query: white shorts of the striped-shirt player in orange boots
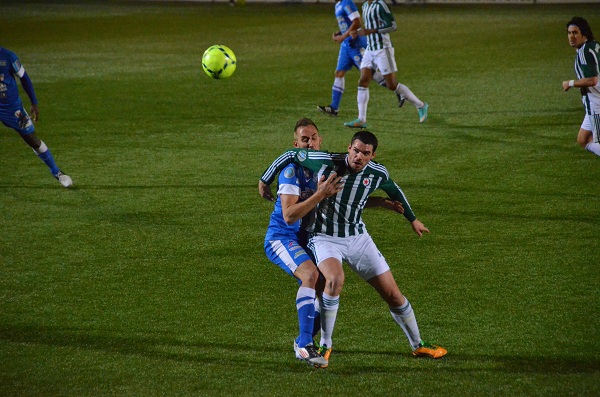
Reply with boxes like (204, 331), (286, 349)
(308, 232), (390, 281)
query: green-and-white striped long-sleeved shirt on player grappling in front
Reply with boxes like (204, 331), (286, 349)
(261, 149), (417, 237)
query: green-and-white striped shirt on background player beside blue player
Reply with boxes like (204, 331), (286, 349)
(362, 0), (396, 51)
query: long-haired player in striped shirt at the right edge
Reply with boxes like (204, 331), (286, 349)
(562, 17), (600, 156)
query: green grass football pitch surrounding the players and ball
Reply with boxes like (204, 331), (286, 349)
(0, 1), (600, 397)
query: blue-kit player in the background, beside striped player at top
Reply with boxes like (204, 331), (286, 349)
(317, 0), (404, 116)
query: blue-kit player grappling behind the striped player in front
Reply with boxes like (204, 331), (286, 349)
(264, 119), (341, 368)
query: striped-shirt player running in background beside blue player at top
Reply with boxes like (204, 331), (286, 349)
(344, 0), (429, 128)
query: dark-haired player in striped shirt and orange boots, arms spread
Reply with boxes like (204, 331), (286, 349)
(261, 130), (447, 358)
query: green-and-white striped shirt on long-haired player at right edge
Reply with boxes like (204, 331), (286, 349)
(575, 40), (600, 114)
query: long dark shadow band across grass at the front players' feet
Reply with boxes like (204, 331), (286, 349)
(0, 325), (600, 375)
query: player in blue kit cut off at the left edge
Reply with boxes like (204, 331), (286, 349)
(0, 47), (73, 187)
